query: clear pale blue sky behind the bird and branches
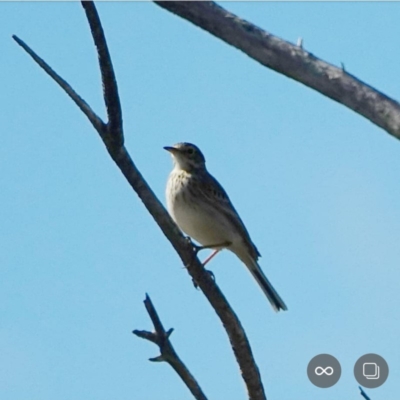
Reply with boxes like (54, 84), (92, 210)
(0, 2), (400, 400)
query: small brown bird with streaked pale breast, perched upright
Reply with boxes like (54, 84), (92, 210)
(164, 142), (287, 311)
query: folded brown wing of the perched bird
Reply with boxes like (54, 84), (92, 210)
(194, 172), (261, 261)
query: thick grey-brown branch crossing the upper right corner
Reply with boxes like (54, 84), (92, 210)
(155, 1), (400, 139)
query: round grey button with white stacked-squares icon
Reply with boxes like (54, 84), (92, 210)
(354, 353), (389, 389)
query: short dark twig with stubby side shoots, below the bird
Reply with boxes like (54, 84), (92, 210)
(133, 294), (207, 400)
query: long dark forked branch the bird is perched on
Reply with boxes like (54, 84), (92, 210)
(13, 1), (266, 400)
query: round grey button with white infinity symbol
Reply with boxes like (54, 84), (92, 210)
(307, 354), (342, 388)
